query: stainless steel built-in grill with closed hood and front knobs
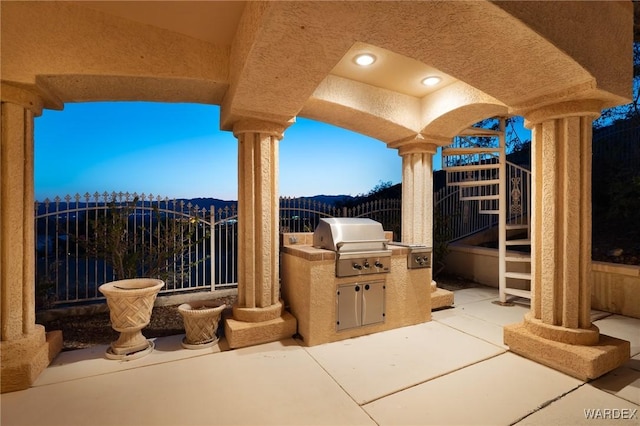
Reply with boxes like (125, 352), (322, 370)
(313, 218), (391, 277)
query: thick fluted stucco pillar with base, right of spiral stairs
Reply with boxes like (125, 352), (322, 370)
(504, 101), (630, 380)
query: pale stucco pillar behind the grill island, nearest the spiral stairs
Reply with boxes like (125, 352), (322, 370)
(390, 135), (453, 309)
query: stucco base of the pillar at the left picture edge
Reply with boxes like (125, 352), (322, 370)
(0, 325), (62, 393)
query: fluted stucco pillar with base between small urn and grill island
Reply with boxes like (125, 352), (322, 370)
(225, 119), (296, 348)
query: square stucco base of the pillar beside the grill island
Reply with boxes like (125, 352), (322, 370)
(224, 310), (298, 349)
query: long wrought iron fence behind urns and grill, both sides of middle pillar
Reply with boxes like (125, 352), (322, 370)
(35, 192), (401, 309)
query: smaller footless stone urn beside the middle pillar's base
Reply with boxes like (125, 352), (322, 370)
(178, 300), (227, 349)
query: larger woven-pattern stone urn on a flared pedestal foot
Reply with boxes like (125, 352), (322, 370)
(98, 278), (164, 360)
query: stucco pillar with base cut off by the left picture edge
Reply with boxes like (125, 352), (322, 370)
(0, 83), (62, 392)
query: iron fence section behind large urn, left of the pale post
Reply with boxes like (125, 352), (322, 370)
(35, 192), (217, 305)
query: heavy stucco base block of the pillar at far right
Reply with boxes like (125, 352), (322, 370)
(504, 323), (631, 381)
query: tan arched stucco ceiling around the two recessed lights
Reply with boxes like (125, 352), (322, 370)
(0, 1), (637, 142)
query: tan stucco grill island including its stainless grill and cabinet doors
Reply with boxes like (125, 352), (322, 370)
(281, 218), (431, 346)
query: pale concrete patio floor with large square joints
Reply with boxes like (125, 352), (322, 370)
(1, 287), (640, 426)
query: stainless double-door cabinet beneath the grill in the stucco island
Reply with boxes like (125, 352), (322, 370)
(336, 281), (385, 331)
